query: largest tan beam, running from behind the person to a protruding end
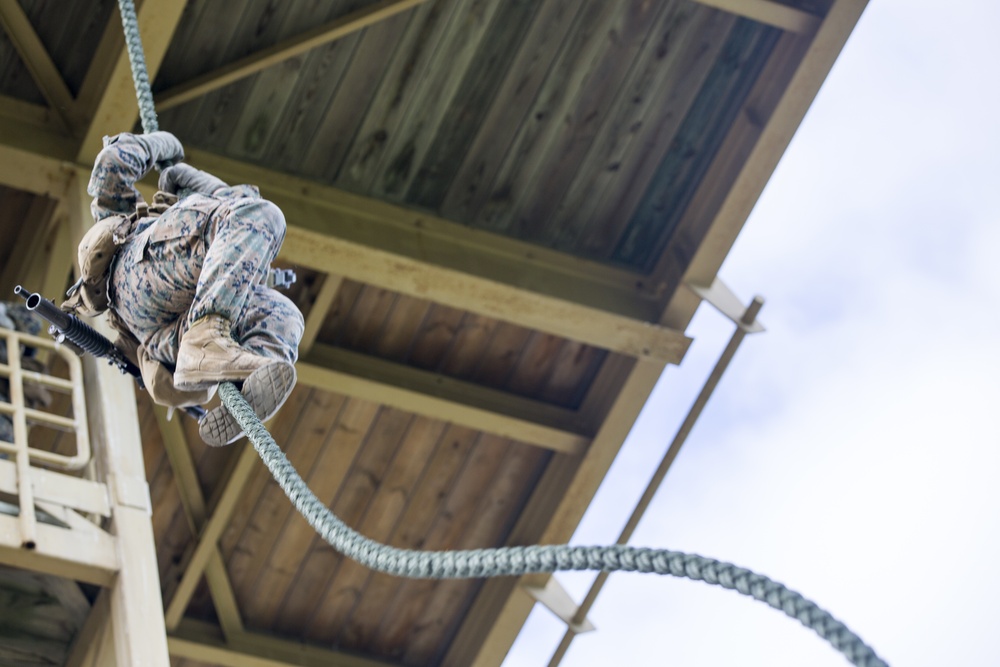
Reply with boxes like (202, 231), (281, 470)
(0, 137), (690, 363)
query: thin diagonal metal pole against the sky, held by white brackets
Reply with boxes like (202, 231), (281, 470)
(549, 297), (764, 667)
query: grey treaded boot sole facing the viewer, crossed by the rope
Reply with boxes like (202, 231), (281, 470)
(198, 361), (296, 447)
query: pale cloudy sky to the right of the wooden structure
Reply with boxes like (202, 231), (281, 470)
(504, 0), (1000, 667)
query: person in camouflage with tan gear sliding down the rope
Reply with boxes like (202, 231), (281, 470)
(63, 132), (304, 446)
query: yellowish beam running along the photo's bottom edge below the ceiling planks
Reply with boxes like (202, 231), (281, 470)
(167, 619), (391, 667)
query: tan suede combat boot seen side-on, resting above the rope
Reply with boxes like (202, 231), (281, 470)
(174, 315), (274, 391)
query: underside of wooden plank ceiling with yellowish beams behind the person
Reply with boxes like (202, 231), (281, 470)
(0, 0), (865, 665)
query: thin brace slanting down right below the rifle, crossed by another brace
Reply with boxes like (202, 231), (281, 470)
(154, 406), (243, 637)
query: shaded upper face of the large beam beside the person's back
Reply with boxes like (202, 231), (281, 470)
(187, 149), (662, 322)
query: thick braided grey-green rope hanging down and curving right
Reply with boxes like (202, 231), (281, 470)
(118, 0), (888, 667)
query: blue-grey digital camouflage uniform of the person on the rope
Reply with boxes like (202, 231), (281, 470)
(88, 134), (304, 365)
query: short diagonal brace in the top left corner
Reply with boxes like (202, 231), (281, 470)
(0, 0), (80, 128)
